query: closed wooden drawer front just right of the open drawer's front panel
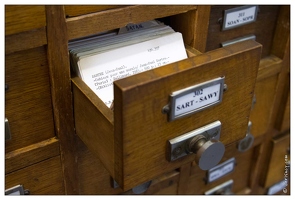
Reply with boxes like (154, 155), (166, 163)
(250, 56), (282, 137)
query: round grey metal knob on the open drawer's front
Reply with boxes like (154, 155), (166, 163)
(188, 135), (225, 170)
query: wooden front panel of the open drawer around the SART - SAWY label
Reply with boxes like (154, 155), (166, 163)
(114, 41), (261, 188)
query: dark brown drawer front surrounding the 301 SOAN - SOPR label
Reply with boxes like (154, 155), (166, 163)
(206, 5), (279, 57)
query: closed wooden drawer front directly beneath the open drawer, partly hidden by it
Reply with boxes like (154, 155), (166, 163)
(77, 137), (179, 195)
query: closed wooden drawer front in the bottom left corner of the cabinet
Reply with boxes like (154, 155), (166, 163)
(5, 156), (65, 195)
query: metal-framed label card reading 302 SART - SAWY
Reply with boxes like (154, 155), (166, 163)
(168, 77), (224, 121)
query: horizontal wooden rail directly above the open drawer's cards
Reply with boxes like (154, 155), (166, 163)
(67, 5), (197, 40)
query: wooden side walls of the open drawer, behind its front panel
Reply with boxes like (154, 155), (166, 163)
(72, 47), (200, 181)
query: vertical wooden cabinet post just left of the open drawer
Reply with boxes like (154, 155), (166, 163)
(46, 6), (79, 194)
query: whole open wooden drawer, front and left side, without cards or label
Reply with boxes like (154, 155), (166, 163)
(72, 41), (261, 191)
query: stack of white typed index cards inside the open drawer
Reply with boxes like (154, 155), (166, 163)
(69, 20), (187, 107)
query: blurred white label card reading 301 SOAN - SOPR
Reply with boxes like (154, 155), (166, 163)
(222, 6), (258, 31)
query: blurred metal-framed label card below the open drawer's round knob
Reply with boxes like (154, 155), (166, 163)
(207, 158), (236, 183)
